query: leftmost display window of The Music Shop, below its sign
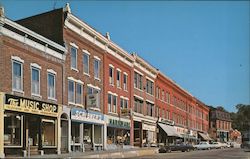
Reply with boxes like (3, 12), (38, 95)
(4, 113), (23, 146)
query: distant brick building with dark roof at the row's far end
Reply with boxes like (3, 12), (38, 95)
(209, 107), (232, 142)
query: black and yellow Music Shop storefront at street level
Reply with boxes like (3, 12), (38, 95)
(4, 94), (59, 156)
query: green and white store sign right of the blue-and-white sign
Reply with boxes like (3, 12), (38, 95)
(105, 115), (130, 129)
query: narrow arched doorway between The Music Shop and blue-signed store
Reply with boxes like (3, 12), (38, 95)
(61, 114), (69, 153)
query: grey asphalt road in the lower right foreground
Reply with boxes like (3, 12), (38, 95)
(133, 148), (250, 159)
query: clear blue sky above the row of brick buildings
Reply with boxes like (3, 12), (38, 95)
(0, 0), (250, 112)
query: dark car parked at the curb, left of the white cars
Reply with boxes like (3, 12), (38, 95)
(159, 144), (195, 153)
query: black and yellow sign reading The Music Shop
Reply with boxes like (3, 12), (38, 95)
(4, 94), (58, 117)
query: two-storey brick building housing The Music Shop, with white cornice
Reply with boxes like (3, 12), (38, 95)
(0, 8), (65, 157)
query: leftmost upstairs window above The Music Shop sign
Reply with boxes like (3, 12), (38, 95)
(12, 60), (23, 91)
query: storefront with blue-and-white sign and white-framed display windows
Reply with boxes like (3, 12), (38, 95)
(71, 108), (105, 151)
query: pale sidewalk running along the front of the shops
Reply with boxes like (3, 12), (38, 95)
(6, 147), (158, 159)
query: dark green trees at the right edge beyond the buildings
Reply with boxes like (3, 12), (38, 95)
(230, 104), (250, 132)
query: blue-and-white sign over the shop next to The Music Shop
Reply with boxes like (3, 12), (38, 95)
(71, 108), (104, 124)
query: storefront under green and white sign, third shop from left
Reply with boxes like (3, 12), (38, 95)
(105, 115), (131, 150)
